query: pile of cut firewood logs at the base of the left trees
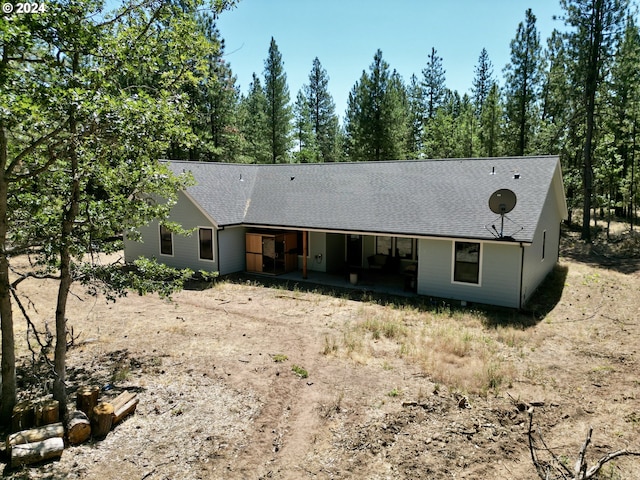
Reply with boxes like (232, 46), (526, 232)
(4, 386), (139, 468)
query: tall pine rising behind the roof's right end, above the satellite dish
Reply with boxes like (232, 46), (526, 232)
(504, 9), (543, 155)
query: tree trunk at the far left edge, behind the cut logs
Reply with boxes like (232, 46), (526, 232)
(0, 121), (16, 425)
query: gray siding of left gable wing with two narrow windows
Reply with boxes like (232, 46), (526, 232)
(124, 192), (219, 271)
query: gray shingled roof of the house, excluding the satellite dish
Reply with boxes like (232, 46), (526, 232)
(168, 156), (566, 242)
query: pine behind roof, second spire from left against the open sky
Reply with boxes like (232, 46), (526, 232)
(306, 57), (338, 162)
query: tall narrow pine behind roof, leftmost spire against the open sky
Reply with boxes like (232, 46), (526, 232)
(264, 37), (292, 163)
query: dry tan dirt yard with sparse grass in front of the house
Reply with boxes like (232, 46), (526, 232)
(4, 230), (640, 480)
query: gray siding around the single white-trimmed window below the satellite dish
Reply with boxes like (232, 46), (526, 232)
(418, 239), (521, 307)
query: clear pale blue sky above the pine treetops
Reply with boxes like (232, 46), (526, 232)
(218, 0), (564, 118)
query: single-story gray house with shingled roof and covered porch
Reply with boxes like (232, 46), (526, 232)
(125, 156), (567, 308)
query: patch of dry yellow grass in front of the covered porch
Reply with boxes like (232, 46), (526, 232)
(322, 304), (535, 395)
